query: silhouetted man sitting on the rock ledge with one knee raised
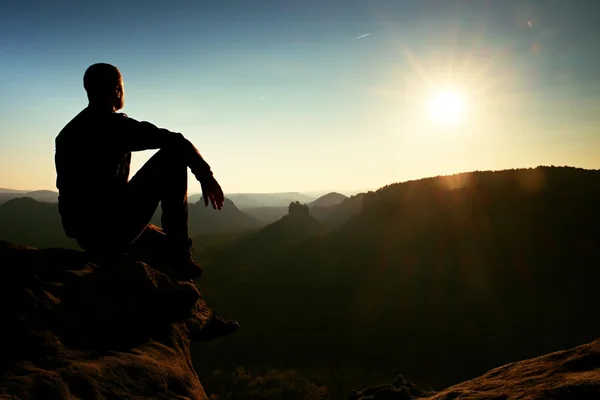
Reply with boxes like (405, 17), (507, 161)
(55, 63), (224, 280)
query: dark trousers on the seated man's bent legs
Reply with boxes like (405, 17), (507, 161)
(77, 150), (189, 252)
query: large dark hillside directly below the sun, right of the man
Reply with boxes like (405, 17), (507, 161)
(194, 167), (600, 387)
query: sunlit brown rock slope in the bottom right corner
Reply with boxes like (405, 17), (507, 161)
(349, 339), (600, 400)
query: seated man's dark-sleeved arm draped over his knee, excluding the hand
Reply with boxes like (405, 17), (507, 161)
(115, 114), (212, 182)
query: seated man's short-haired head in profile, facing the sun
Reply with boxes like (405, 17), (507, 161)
(83, 63), (125, 111)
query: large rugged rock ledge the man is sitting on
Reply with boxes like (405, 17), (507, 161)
(0, 242), (238, 400)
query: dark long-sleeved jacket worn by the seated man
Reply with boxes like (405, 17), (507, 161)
(55, 107), (212, 238)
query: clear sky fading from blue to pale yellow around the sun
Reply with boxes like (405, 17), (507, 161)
(0, 0), (600, 193)
